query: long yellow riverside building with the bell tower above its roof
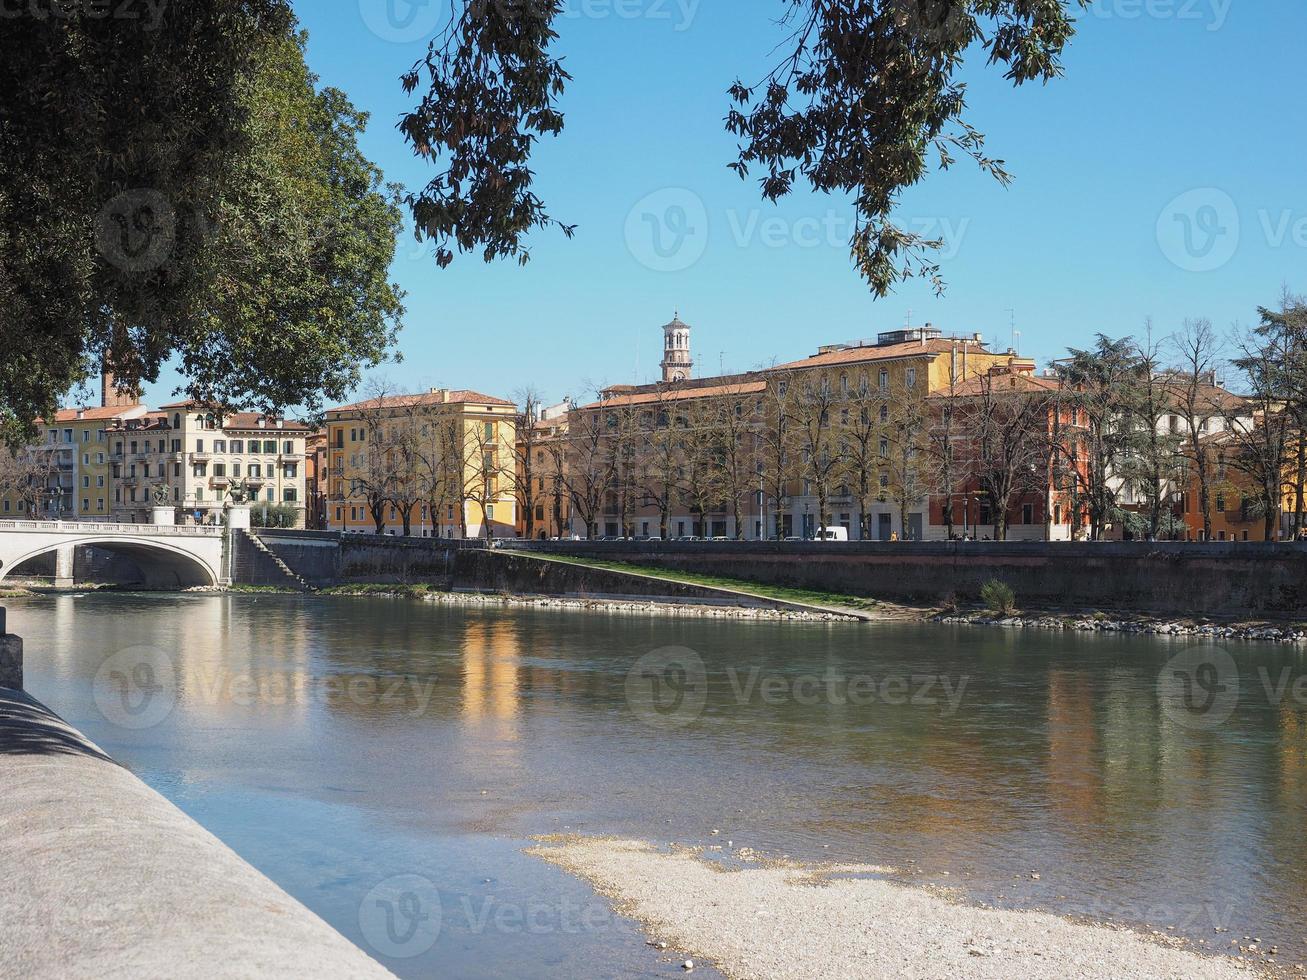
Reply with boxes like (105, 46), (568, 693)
(567, 318), (1034, 540)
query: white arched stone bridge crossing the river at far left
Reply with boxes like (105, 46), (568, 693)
(0, 520), (231, 588)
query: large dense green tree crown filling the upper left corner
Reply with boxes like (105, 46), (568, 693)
(0, 7), (401, 439)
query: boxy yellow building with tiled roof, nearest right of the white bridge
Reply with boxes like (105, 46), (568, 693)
(325, 388), (518, 538)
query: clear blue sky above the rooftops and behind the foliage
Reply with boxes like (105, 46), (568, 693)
(137, 0), (1307, 401)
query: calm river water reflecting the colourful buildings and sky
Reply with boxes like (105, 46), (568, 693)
(8, 595), (1307, 977)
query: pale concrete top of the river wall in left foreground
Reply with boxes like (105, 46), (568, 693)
(0, 690), (391, 980)
